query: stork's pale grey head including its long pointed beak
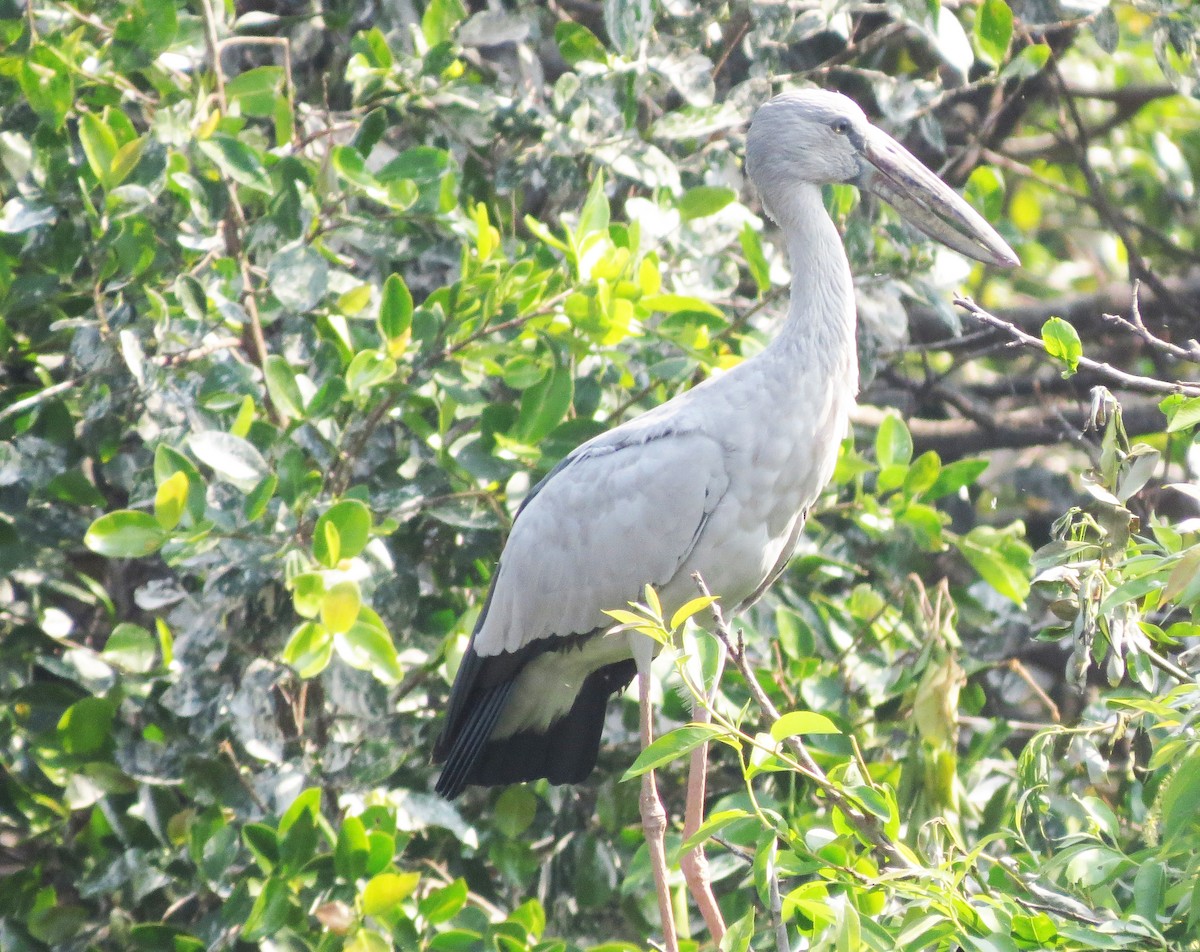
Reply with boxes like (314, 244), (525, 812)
(746, 89), (1020, 268)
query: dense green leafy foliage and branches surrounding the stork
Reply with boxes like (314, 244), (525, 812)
(0, 0), (1200, 952)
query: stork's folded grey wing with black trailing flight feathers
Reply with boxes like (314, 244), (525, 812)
(434, 418), (728, 797)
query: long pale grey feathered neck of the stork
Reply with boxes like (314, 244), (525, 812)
(770, 185), (858, 394)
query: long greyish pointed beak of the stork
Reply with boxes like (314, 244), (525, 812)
(858, 126), (1021, 268)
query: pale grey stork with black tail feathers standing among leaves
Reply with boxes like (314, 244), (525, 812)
(434, 89), (1019, 941)
